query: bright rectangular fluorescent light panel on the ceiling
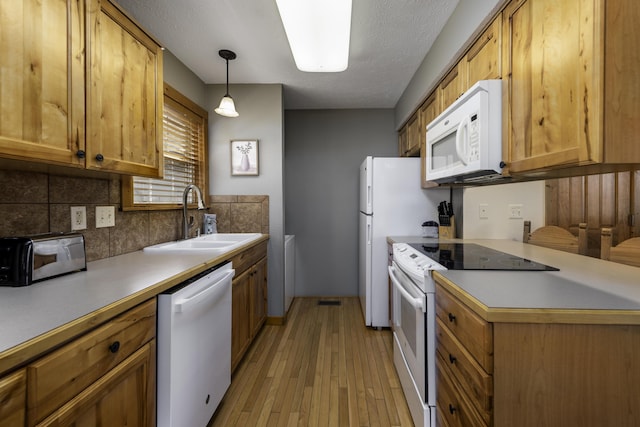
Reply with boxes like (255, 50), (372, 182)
(276, 0), (352, 73)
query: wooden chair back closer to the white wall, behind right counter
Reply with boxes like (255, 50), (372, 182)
(522, 221), (587, 255)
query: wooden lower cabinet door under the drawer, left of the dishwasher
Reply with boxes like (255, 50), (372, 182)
(38, 339), (156, 427)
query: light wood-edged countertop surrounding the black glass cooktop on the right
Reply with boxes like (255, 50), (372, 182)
(389, 237), (640, 324)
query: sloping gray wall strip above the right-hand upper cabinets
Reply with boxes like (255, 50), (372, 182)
(395, 0), (506, 129)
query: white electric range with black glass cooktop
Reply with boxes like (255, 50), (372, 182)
(389, 240), (557, 427)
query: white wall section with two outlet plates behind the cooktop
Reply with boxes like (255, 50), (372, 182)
(462, 181), (545, 241)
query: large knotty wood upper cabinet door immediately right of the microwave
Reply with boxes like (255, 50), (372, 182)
(503, 0), (602, 176)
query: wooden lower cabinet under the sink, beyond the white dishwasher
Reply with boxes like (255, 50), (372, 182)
(231, 242), (267, 372)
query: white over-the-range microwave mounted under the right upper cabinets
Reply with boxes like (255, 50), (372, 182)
(425, 80), (504, 184)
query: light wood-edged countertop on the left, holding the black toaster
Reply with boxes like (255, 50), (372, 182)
(0, 235), (268, 374)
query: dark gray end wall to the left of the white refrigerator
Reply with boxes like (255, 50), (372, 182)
(285, 109), (398, 296)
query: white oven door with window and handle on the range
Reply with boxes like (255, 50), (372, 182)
(389, 262), (427, 403)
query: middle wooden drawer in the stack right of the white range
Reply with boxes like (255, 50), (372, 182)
(436, 318), (493, 423)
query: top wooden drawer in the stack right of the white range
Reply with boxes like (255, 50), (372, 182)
(436, 283), (493, 374)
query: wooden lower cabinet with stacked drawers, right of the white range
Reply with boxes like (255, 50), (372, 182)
(436, 283), (640, 427)
